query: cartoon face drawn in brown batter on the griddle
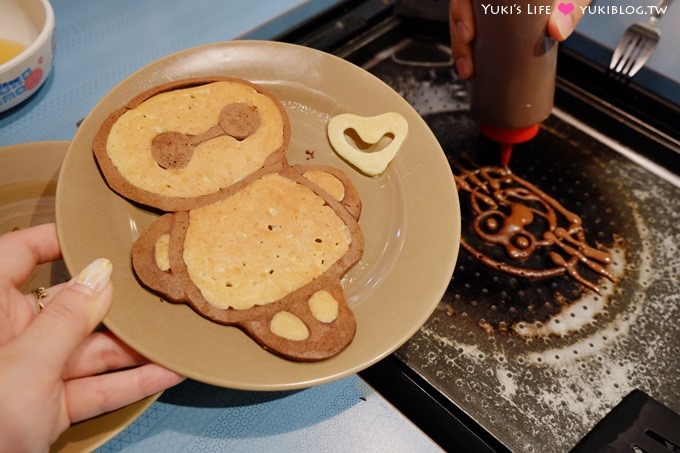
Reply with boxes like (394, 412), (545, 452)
(453, 162), (615, 293)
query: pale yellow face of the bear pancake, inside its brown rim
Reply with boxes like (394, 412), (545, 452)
(106, 81), (285, 197)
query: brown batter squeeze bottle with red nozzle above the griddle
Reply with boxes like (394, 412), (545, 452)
(470, 0), (557, 166)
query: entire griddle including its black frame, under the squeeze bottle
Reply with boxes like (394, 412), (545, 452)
(276, 1), (680, 452)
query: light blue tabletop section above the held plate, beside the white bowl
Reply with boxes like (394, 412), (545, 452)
(0, 0), (346, 146)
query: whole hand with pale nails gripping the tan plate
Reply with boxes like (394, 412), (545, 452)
(0, 224), (183, 451)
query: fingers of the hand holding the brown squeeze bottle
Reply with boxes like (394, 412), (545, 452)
(449, 0), (591, 79)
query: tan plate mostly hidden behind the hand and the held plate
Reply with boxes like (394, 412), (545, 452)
(0, 141), (160, 452)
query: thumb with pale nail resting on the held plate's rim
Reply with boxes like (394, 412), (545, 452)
(20, 258), (113, 373)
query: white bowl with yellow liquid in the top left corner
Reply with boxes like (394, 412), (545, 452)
(0, 0), (54, 112)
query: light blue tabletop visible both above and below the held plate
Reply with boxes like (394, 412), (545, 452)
(0, 0), (439, 452)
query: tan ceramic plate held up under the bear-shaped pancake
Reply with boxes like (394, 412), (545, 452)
(57, 41), (460, 390)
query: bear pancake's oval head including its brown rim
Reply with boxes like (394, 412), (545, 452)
(94, 77), (290, 211)
